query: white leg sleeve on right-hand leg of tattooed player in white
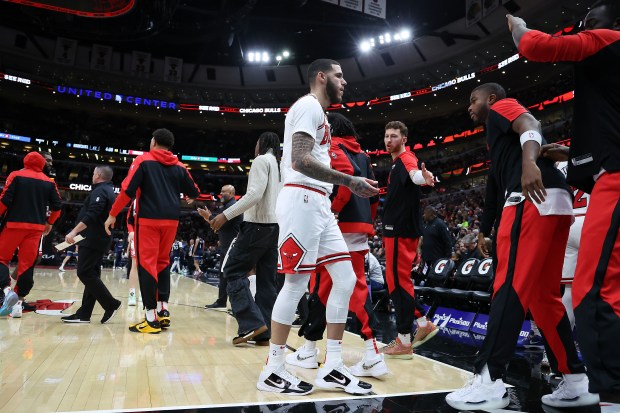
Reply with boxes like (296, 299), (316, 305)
(325, 261), (356, 324)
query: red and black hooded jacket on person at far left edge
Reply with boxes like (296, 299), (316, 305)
(0, 152), (62, 231)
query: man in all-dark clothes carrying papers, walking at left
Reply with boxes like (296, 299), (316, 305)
(62, 166), (121, 324)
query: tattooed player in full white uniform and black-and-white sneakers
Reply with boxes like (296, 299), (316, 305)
(256, 59), (379, 396)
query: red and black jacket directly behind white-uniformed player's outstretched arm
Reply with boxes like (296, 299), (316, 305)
(329, 136), (379, 235)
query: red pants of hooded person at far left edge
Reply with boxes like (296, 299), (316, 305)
(0, 228), (43, 297)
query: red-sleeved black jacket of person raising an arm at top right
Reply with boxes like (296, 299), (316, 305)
(519, 29), (620, 193)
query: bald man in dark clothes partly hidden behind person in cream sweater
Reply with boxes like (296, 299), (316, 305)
(205, 185), (243, 309)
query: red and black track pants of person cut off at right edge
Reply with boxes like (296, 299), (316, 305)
(573, 172), (620, 394)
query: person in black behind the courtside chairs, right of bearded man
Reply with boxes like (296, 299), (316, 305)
(419, 206), (454, 274)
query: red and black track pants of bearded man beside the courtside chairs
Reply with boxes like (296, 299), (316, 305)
(383, 237), (422, 334)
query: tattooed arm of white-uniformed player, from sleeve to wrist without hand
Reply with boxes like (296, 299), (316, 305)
(291, 132), (352, 186)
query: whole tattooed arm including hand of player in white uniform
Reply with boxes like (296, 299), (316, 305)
(291, 132), (379, 198)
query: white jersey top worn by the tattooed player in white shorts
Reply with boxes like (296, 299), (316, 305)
(280, 95), (333, 193)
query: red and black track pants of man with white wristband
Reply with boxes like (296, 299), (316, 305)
(474, 201), (585, 380)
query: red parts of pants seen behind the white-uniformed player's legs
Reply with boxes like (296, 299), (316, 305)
(310, 250), (374, 340)
